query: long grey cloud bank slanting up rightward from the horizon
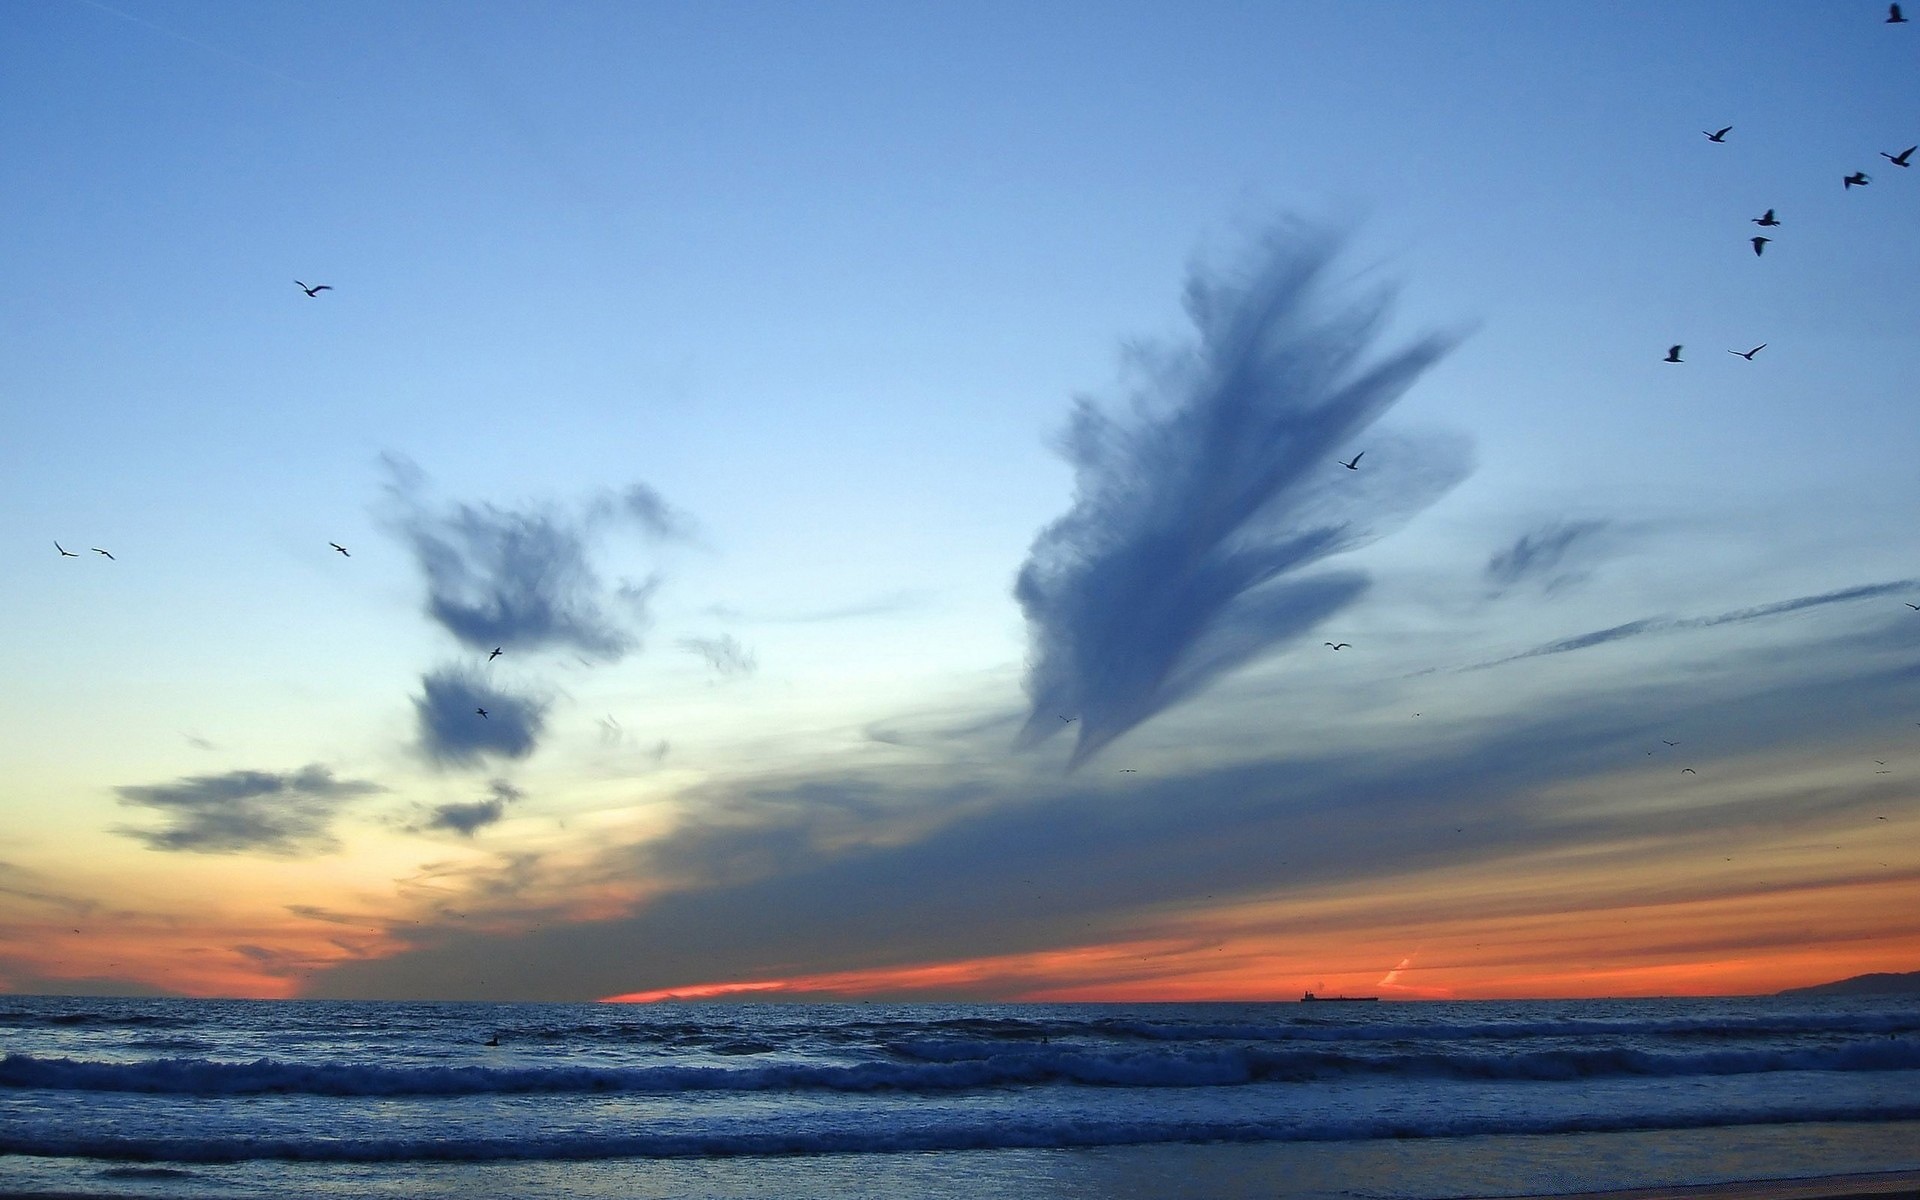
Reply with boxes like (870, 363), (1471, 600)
(303, 606), (1920, 1000)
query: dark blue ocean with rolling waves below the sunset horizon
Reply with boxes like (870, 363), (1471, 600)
(0, 996), (1920, 1200)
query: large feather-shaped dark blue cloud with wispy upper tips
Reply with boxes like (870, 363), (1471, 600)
(1014, 228), (1471, 764)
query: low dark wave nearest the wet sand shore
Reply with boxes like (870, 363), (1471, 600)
(0, 1100), (1920, 1164)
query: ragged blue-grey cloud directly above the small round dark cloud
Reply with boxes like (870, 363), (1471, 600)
(386, 457), (685, 660)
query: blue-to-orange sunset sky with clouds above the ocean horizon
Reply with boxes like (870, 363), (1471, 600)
(0, 0), (1920, 1000)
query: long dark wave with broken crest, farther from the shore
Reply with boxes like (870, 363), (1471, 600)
(0, 1039), (1920, 1096)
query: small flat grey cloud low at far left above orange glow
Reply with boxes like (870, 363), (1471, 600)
(115, 764), (386, 858)
